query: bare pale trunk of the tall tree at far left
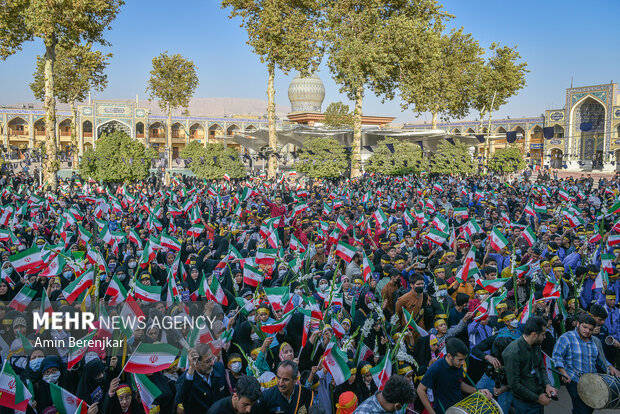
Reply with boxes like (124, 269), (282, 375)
(42, 40), (59, 191)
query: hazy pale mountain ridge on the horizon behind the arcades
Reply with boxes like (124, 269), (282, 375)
(6, 98), (291, 118)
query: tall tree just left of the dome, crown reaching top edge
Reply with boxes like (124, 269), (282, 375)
(222, 0), (324, 178)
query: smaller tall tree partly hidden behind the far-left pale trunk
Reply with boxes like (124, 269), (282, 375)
(30, 43), (112, 167)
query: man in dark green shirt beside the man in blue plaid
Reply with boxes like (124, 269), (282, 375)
(502, 316), (557, 414)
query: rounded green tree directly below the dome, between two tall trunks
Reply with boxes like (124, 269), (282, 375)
(294, 138), (349, 178)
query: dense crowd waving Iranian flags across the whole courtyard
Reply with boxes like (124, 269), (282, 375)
(0, 172), (620, 414)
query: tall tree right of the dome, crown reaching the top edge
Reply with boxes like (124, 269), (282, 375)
(325, 0), (444, 177)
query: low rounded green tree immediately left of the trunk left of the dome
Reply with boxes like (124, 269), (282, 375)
(180, 141), (246, 180)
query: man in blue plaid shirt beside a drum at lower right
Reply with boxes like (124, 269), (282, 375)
(553, 313), (620, 414)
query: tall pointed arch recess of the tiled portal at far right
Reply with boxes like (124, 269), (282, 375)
(574, 97), (605, 169)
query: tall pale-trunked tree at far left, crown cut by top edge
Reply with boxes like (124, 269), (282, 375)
(0, 0), (124, 190)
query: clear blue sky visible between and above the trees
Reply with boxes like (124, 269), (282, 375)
(0, 0), (620, 123)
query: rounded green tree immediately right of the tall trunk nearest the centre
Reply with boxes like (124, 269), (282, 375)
(364, 137), (424, 175)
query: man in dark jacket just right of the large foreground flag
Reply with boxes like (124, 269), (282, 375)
(177, 344), (230, 413)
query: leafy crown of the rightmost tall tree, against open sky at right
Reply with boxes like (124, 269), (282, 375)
(472, 43), (529, 114)
